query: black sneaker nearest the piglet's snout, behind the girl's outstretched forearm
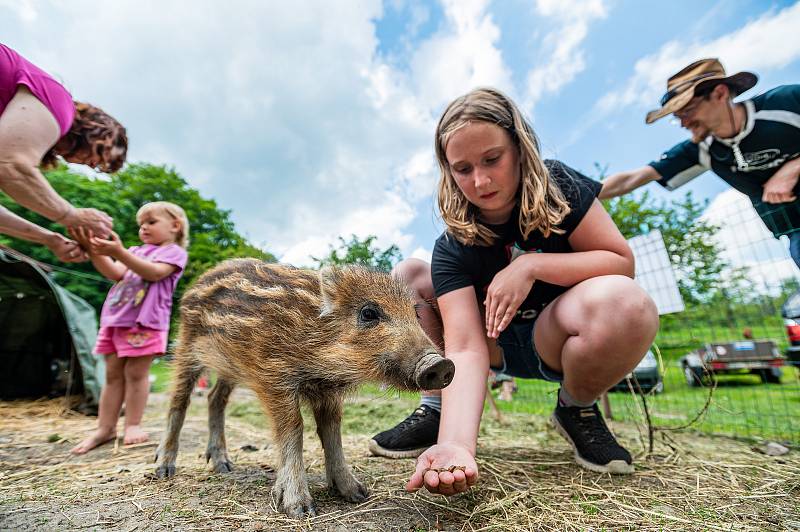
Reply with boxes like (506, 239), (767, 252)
(369, 405), (440, 458)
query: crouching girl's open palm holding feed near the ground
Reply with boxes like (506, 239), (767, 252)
(406, 443), (478, 495)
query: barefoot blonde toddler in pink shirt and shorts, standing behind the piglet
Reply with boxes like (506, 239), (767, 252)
(71, 201), (189, 454)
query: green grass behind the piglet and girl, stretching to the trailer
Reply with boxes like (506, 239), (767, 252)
(150, 351), (800, 443)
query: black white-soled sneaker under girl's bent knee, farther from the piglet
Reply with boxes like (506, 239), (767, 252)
(551, 403), (634, 475)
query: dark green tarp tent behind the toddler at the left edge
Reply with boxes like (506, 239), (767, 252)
(0, 246), (105, 413)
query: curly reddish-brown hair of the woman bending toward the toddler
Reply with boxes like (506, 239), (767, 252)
(42, 102), (128, 173)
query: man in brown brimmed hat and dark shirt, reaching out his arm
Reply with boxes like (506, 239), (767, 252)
(600, 59), (800, 267)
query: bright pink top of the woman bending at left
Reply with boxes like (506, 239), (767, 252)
(0, 44), (75, 137)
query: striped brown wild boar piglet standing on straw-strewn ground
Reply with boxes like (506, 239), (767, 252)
(156, 259), (455, 517)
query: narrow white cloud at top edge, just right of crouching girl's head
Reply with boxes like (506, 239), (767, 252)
(524, 0), (606, 109)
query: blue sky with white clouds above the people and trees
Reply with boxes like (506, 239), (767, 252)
(0, 0), (800, 264)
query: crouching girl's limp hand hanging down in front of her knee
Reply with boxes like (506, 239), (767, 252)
(483, 253), (536, 338)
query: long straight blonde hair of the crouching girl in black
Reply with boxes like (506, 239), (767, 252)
(435, 88), (570, 246)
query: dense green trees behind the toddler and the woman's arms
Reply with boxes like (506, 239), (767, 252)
(0, 164), (275, 311)
